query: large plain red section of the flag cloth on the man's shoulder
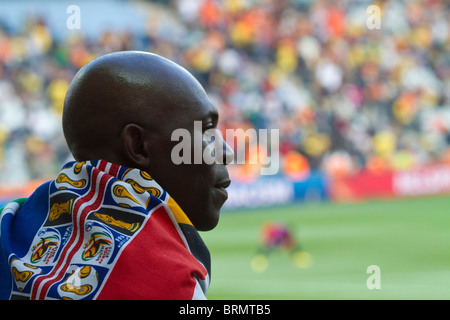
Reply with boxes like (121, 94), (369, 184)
(97, 207), (207, 300)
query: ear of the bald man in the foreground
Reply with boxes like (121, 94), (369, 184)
(121, 123), (150, 168)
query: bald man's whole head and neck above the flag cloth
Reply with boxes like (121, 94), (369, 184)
(63, 51), (233, 231)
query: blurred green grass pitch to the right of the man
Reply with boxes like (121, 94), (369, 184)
(202, 197), (450, 300)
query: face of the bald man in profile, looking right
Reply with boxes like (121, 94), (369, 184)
(147, 87), (233, 231)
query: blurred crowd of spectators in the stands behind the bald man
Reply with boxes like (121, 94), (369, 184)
(0, 0), (450, 183)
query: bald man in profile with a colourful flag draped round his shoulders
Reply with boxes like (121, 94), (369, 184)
(0, 51), (233, 299)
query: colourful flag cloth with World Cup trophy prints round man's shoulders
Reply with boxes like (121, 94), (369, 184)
(0, 160), (210, 300)
